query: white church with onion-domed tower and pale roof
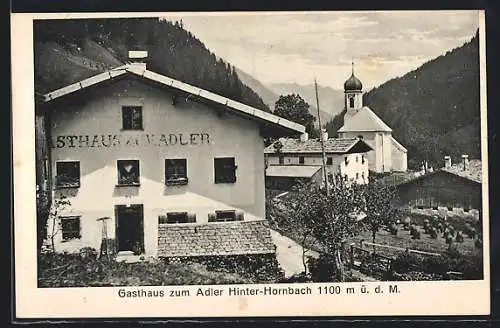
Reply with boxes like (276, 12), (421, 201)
(337, 66), (407, 173)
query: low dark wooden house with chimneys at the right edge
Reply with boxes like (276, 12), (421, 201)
(383, 155), (482, 218)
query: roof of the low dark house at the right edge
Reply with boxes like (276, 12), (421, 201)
(380, 159), (482, 186)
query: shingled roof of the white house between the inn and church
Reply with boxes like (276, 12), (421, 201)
(264, 138), (372, 154)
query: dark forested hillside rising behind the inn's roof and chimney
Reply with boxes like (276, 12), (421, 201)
(34, 18), (269, 111)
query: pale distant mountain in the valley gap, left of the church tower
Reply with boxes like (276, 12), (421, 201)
(268, 83), (344, 124)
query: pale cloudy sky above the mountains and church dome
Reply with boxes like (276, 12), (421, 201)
(165, 11), (479, 90)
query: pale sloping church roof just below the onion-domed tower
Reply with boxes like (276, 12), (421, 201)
(337, 106), (392, 132)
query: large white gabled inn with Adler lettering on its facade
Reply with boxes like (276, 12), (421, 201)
(37, 54), (305, 258)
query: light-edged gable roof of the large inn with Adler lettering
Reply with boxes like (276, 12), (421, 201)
(42, 63), (305, 133)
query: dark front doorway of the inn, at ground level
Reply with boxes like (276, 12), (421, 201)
(115, 204), (144, 254)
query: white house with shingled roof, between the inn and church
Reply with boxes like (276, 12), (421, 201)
(265, 132), (372, 190)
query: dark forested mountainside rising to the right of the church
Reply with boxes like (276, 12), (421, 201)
(328, 32), (481, 167)
